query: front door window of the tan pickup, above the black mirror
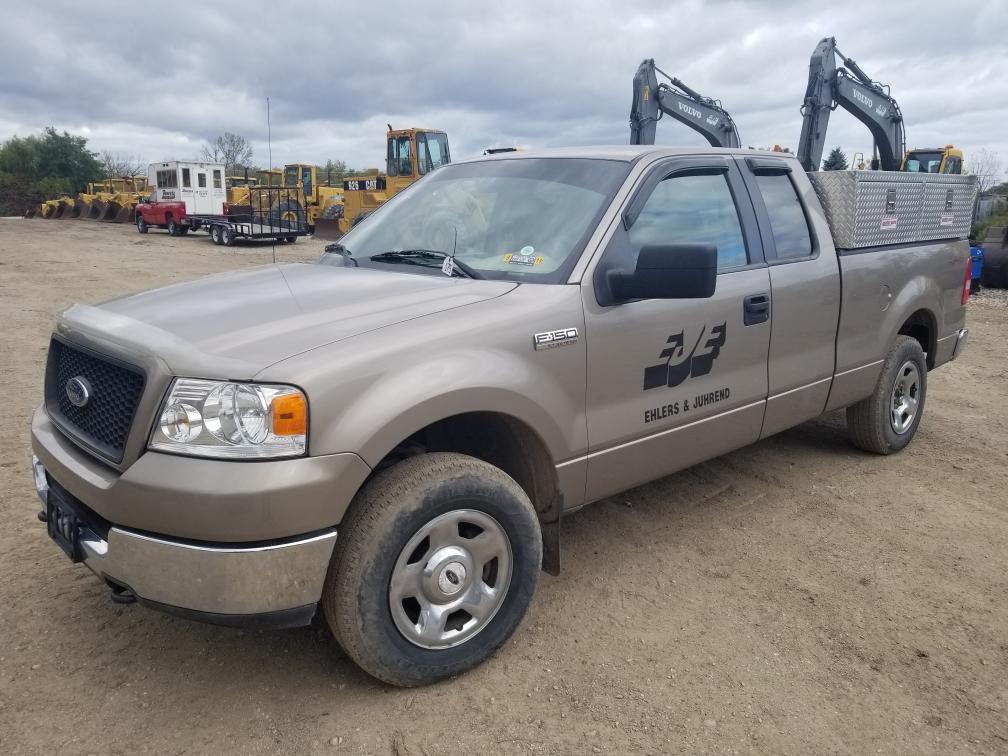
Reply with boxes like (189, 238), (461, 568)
(629, 172), (749, 271)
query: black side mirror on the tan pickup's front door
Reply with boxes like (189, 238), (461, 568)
(608, 244), (718, 302)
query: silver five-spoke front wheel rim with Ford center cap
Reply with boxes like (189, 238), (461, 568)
(388, 509), (513, 650)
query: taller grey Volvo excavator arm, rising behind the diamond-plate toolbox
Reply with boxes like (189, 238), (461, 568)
(797, 37), (906, 170)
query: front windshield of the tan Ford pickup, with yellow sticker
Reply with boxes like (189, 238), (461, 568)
(323, 158), (630, 283)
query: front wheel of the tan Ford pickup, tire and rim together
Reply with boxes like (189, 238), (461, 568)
(322, 453), (542, 686)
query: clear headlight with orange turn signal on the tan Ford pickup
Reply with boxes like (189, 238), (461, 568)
(148, 378), (308, 460)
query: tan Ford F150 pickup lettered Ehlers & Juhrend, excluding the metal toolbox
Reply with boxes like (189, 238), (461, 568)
(31, 146), (970, 685)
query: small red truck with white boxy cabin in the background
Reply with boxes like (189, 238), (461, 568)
(136, 160), (227, 236)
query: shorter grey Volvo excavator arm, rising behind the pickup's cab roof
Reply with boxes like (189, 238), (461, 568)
(630, 58), (741, 147)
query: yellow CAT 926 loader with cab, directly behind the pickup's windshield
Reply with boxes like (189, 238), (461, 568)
(312, 125), (452, 239)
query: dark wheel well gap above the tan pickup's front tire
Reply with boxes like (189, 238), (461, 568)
(369, 411), (558, 520)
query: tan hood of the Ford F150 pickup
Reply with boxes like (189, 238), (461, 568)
(57, 263), (517, 379)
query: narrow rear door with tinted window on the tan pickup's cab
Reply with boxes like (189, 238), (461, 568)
(737, 156), (840, 437)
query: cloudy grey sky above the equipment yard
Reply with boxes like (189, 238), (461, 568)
(0, 0), (1008, 173)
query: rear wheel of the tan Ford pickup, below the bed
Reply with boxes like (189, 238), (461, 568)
(847, 335), (927, 455)
